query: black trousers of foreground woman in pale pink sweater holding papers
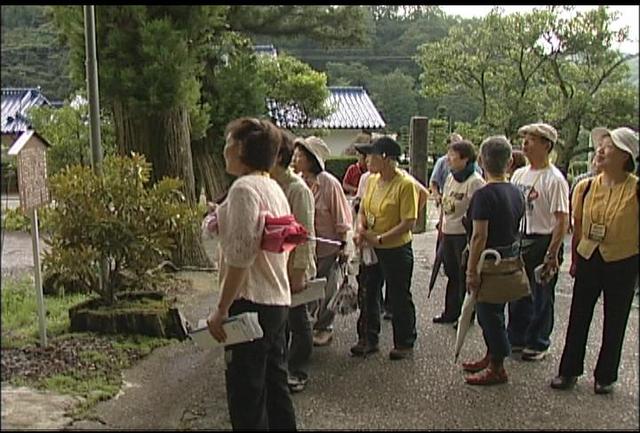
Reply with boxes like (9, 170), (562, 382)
(225, 299), (296, 430)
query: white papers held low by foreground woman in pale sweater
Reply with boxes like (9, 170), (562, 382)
(189, 311), (264, 349)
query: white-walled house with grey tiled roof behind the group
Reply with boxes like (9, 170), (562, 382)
(267, 86), (386, 156)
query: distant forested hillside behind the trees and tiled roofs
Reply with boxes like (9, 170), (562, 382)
(1, 6), (638, 147)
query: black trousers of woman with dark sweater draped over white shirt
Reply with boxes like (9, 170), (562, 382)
(442, 234), (467, 321)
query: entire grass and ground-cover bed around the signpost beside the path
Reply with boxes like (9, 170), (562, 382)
(1, 275), (176, 419)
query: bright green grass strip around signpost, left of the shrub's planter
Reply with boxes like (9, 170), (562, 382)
(0, 275), (91, 348)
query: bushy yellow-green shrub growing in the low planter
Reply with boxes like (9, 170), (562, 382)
(43, 155), (195, 304)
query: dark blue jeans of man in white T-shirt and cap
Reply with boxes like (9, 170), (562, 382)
(507, 235), (563, 351)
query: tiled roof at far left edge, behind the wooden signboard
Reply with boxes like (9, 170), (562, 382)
(2, 88), (51, 134)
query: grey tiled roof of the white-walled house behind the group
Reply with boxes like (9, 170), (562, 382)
(267, 87), (386, 129)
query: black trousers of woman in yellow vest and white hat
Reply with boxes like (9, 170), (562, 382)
(560, 250), (638, 384)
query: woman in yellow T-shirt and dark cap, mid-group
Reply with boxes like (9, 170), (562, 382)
(351, 137), (418, 360)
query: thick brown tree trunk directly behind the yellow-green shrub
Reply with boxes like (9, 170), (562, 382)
(114, 102), (211, 267)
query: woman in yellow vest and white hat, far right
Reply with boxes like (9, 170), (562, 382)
(551, 128), (638, 394)
